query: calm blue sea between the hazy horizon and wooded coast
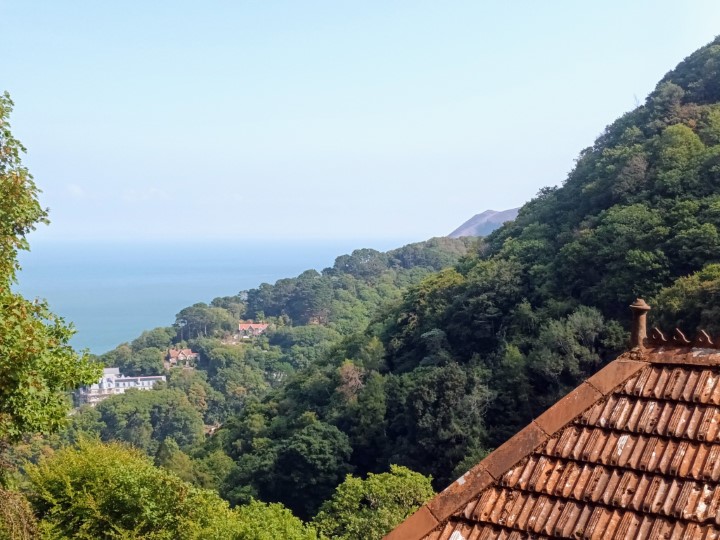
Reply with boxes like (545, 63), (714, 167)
(14, 238), (408, 354)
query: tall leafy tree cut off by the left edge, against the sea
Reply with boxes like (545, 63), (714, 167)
(0, 93), (100, 445)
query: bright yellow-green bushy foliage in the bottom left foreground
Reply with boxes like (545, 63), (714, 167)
(28, 440), (238, 539)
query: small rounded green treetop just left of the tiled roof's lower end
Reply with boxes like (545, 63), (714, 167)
(313, 465), (434, 540)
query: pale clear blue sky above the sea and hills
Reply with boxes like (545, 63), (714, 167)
(0, 0), (720, 240)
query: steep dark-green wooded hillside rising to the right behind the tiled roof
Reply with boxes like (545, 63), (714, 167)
(211, 34), (720, 512)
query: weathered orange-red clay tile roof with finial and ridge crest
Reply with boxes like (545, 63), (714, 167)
(386, 302), (720, 540)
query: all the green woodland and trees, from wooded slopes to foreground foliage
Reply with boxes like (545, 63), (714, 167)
(0, 38), (720, 539)
